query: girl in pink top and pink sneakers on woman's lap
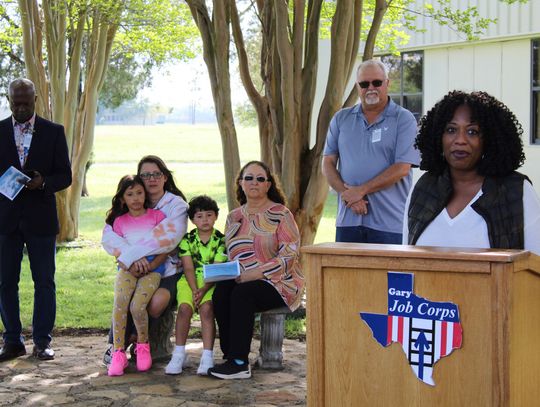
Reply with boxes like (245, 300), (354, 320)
(105, 175), (167, 376)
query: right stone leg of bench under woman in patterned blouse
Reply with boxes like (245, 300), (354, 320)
(255, 307), (291, 370)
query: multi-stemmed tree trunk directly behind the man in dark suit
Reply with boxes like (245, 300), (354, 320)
(18, 0), (121, 241)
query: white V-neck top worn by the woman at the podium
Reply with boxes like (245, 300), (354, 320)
(403, 181), (540, 255)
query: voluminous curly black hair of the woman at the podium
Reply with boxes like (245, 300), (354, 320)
(415, 90), (525, 176)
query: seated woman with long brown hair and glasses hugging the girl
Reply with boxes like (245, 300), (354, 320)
(102, 155), (188, 364)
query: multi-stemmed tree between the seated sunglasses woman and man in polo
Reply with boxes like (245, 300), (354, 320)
(186, 0), (517, 244)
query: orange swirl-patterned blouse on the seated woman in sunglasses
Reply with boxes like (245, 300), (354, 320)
(225, 203), (304, 311)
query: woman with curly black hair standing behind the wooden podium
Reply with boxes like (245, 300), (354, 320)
(403, 91), (540, 254)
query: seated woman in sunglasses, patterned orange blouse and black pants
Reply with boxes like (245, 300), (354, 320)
(208, 161), (304, 379)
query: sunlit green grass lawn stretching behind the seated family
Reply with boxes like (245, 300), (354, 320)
(7, 125), (336, 330)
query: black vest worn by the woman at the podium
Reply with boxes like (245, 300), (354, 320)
(408, 170), (528, 249)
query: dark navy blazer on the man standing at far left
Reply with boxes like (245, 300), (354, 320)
(0, 115), (71, 236)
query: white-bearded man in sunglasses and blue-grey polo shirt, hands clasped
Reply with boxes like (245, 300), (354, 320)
(322, 59), (420, 244)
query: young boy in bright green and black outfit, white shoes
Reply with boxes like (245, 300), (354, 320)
(165, 195), (227, 375)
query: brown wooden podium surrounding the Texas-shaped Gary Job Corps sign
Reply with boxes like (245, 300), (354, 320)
(302, 243), (540, 407)
